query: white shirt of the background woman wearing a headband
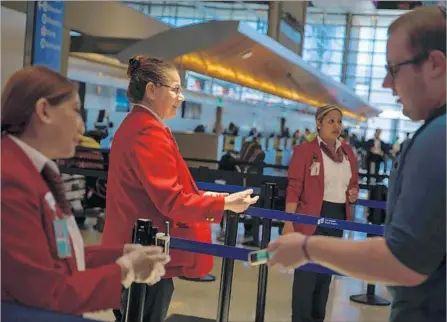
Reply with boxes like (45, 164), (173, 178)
(318, 136), (352, 203)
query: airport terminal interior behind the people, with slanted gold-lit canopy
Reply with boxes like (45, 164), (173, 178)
(1, 0), (442, 322)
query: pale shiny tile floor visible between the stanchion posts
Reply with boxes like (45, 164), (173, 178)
(83, 200), (389, 322)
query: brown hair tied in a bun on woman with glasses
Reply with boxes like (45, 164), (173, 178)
(127, 56), (177, 103)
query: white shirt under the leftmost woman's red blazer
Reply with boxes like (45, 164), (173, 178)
(9, 135), (85, 271)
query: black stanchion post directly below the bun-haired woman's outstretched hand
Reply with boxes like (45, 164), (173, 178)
(216, 211), (239, 322)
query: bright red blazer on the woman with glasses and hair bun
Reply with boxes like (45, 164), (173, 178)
(102, 106), (224, 277)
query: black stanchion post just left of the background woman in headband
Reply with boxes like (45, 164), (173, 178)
(255, 183), (278, 322)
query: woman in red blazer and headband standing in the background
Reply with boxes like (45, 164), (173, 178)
(284, 105), (359, 322)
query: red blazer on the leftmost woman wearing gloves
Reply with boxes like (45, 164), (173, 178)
(1, 136), (123, 314)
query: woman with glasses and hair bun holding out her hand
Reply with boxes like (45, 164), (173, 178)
(102, 56), (258, 322)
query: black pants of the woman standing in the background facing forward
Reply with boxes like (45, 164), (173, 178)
(292, 201), (346, 322)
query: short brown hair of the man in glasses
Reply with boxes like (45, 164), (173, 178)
(388, 6), (446, 55)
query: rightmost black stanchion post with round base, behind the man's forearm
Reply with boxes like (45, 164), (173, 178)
(349, 185), (390, 306)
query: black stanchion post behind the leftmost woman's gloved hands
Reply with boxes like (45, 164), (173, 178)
(122, 219), (156, 322)
